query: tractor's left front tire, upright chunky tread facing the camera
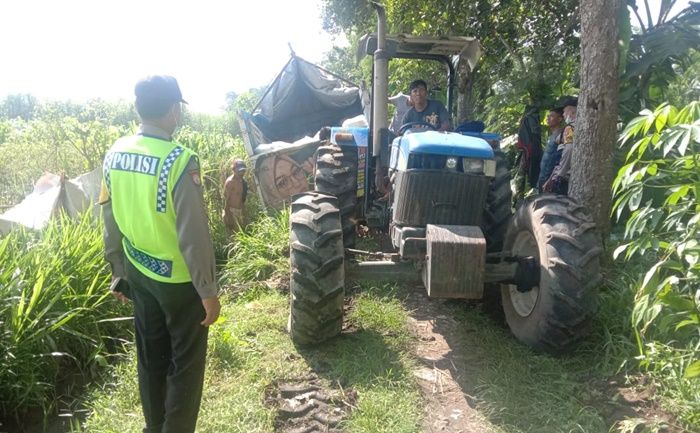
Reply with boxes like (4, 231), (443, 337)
(289, 192), (345, 346)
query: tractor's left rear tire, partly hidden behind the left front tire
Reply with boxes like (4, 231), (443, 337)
(314, 144), (357, 248)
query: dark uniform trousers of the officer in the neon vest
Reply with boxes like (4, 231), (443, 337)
(125, 259), (208, 433)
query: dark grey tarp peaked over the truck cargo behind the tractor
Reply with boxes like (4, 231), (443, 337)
(243, 56), (362, 153)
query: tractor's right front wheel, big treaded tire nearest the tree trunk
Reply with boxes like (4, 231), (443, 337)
(501, 194), (602, 354)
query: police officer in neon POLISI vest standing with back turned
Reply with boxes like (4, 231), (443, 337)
(100, 76), (221, 433)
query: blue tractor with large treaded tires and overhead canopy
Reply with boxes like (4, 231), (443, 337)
(289, 5), (601, 353)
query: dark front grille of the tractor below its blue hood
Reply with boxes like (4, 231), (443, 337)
(393, 170), (491, 226)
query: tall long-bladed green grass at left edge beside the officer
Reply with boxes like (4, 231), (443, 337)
(0, 213), (130, 419)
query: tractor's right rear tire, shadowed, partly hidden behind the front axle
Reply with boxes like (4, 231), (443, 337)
(481, 151), (513, 316)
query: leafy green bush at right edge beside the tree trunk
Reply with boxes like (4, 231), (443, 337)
(613, 102), (700, 424)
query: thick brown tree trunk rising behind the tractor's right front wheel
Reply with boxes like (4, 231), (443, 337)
(569, 0), (620, 234)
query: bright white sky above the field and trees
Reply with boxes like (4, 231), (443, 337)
(0, 0), (688, 113)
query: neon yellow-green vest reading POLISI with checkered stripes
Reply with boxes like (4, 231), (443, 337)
(103, 135), (196, 283)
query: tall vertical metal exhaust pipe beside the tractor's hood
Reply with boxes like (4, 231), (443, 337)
(372, 1), (389, 156)
